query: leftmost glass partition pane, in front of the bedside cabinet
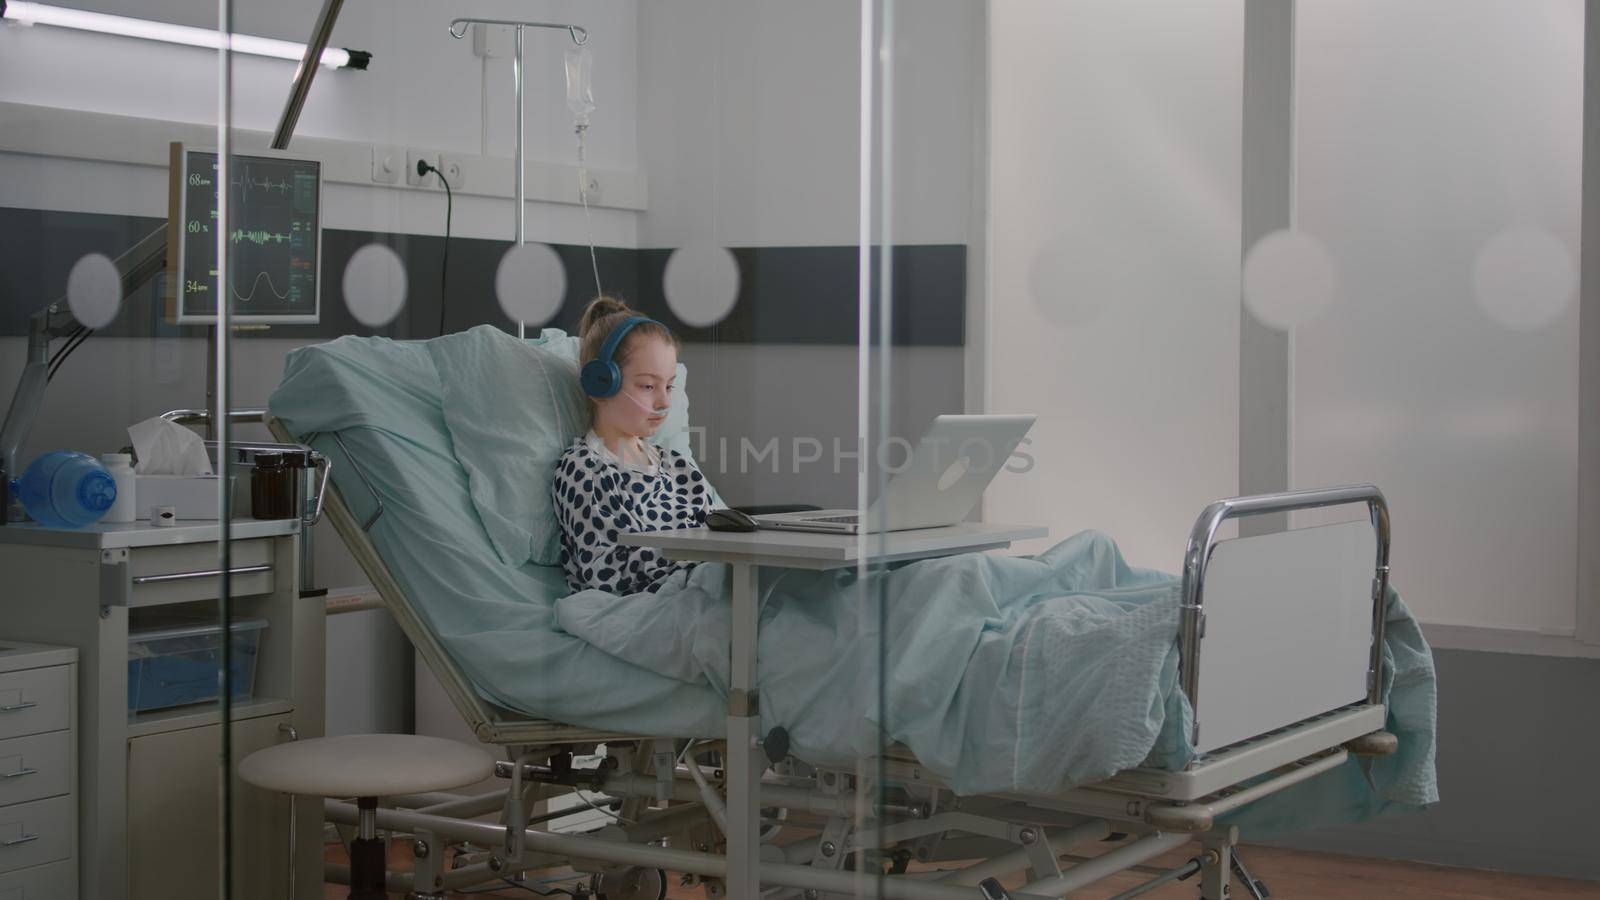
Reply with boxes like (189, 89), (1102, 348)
(0, 2), (251, 897)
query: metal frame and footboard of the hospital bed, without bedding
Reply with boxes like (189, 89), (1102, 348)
(269, 337), (1397, 900)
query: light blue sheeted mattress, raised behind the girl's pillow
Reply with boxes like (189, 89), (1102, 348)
(269, 338), (723, 737)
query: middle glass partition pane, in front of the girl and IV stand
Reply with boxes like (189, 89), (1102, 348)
(251, 2), (902, 897)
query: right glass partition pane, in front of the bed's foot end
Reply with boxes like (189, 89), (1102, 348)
(861, 0), (1594, 897)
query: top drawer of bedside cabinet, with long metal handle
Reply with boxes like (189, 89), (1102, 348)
(128, 538), (274, 607)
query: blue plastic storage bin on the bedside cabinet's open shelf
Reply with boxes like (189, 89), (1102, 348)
(128, 618), (267, 714)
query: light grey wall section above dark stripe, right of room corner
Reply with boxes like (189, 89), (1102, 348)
(638, 0), (984, 247)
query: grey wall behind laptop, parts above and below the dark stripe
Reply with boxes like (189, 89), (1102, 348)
(638, 0), (984, 506)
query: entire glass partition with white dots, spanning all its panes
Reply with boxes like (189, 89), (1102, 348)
(0, 0), (1594, 898)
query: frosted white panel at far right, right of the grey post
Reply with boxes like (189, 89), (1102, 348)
(1291, 0), (1584, 634)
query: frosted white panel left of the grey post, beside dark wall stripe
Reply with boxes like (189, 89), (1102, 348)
(986, 0), (1243, 570)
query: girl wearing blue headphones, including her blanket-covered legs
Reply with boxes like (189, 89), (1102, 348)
(550, 296), (1203, 788)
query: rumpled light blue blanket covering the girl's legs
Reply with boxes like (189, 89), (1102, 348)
(557, 532), (1187, 793)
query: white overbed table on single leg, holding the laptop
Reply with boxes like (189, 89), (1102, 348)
(618, 522), (1048, 898)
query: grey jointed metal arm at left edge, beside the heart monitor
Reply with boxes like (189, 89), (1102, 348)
(0, 224), (166, 525)
